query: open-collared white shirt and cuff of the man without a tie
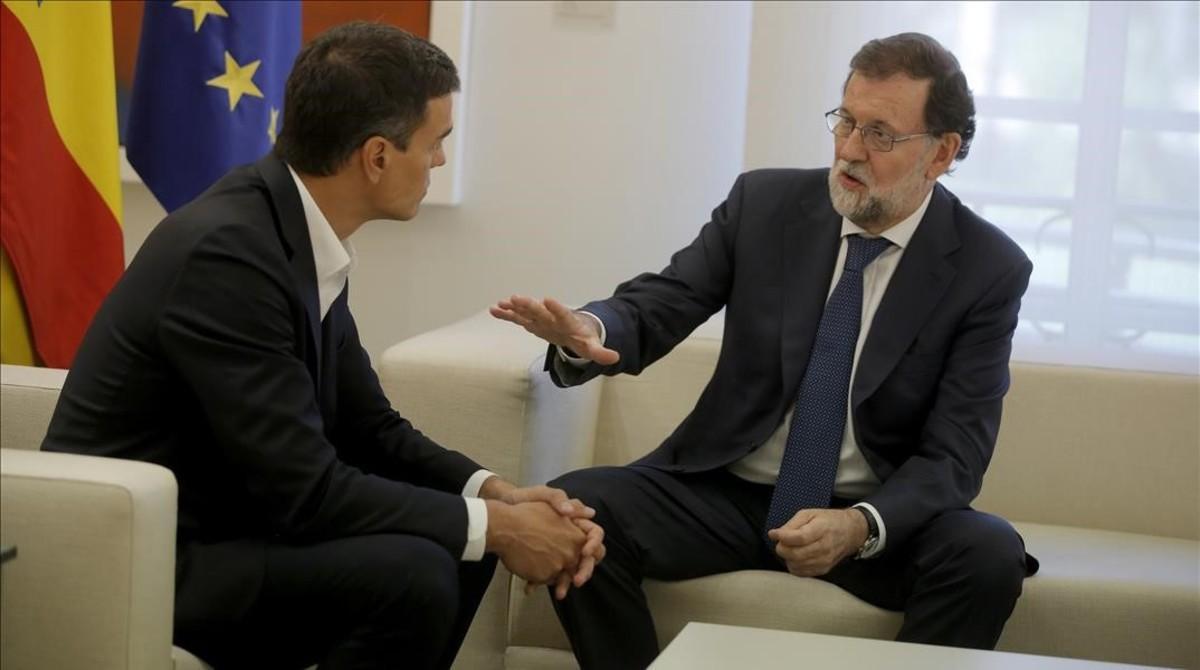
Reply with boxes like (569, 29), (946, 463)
(288, 166), (494, 561)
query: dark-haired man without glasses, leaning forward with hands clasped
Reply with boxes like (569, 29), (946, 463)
(43, 23), (604, 668)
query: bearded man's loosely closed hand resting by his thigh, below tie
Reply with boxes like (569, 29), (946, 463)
(767, 509), (868, 576)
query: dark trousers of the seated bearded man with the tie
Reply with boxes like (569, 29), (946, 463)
(552, 466), (1026, 670)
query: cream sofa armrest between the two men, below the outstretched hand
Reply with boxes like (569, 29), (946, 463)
(378, 312), (600, 484)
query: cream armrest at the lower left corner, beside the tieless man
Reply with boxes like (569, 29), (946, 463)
(0, 449), (178, 670)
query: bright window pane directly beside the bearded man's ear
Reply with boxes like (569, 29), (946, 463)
(944, 119), (1079, 198)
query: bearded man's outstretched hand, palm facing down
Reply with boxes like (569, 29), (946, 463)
(488, 295), (620, 365)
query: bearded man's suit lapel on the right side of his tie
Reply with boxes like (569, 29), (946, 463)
(851, 185), (959, 407)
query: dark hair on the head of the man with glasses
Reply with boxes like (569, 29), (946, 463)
(842, 32), (974, 161)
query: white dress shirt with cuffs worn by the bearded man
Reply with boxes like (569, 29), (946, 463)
(558, 186), (934, 558)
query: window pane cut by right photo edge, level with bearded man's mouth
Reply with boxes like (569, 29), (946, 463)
(1117, 131), (1200, 206)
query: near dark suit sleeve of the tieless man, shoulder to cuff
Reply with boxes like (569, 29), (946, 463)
(158, 226), (467, 556)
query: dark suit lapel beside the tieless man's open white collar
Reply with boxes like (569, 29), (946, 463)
(256, 154), (322, 393)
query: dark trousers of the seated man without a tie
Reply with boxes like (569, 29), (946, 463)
(175, 534), (496, 670)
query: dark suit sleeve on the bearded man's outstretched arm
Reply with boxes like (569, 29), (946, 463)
(546, 175), (745, 387)
